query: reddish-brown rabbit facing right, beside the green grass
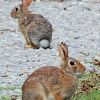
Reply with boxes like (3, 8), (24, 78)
(22, 43), (85, 100)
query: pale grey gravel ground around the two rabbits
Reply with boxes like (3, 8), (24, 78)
(0, 0), (100, 97)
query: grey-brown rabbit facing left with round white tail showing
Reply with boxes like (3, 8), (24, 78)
(11, 0), (52, 49)
